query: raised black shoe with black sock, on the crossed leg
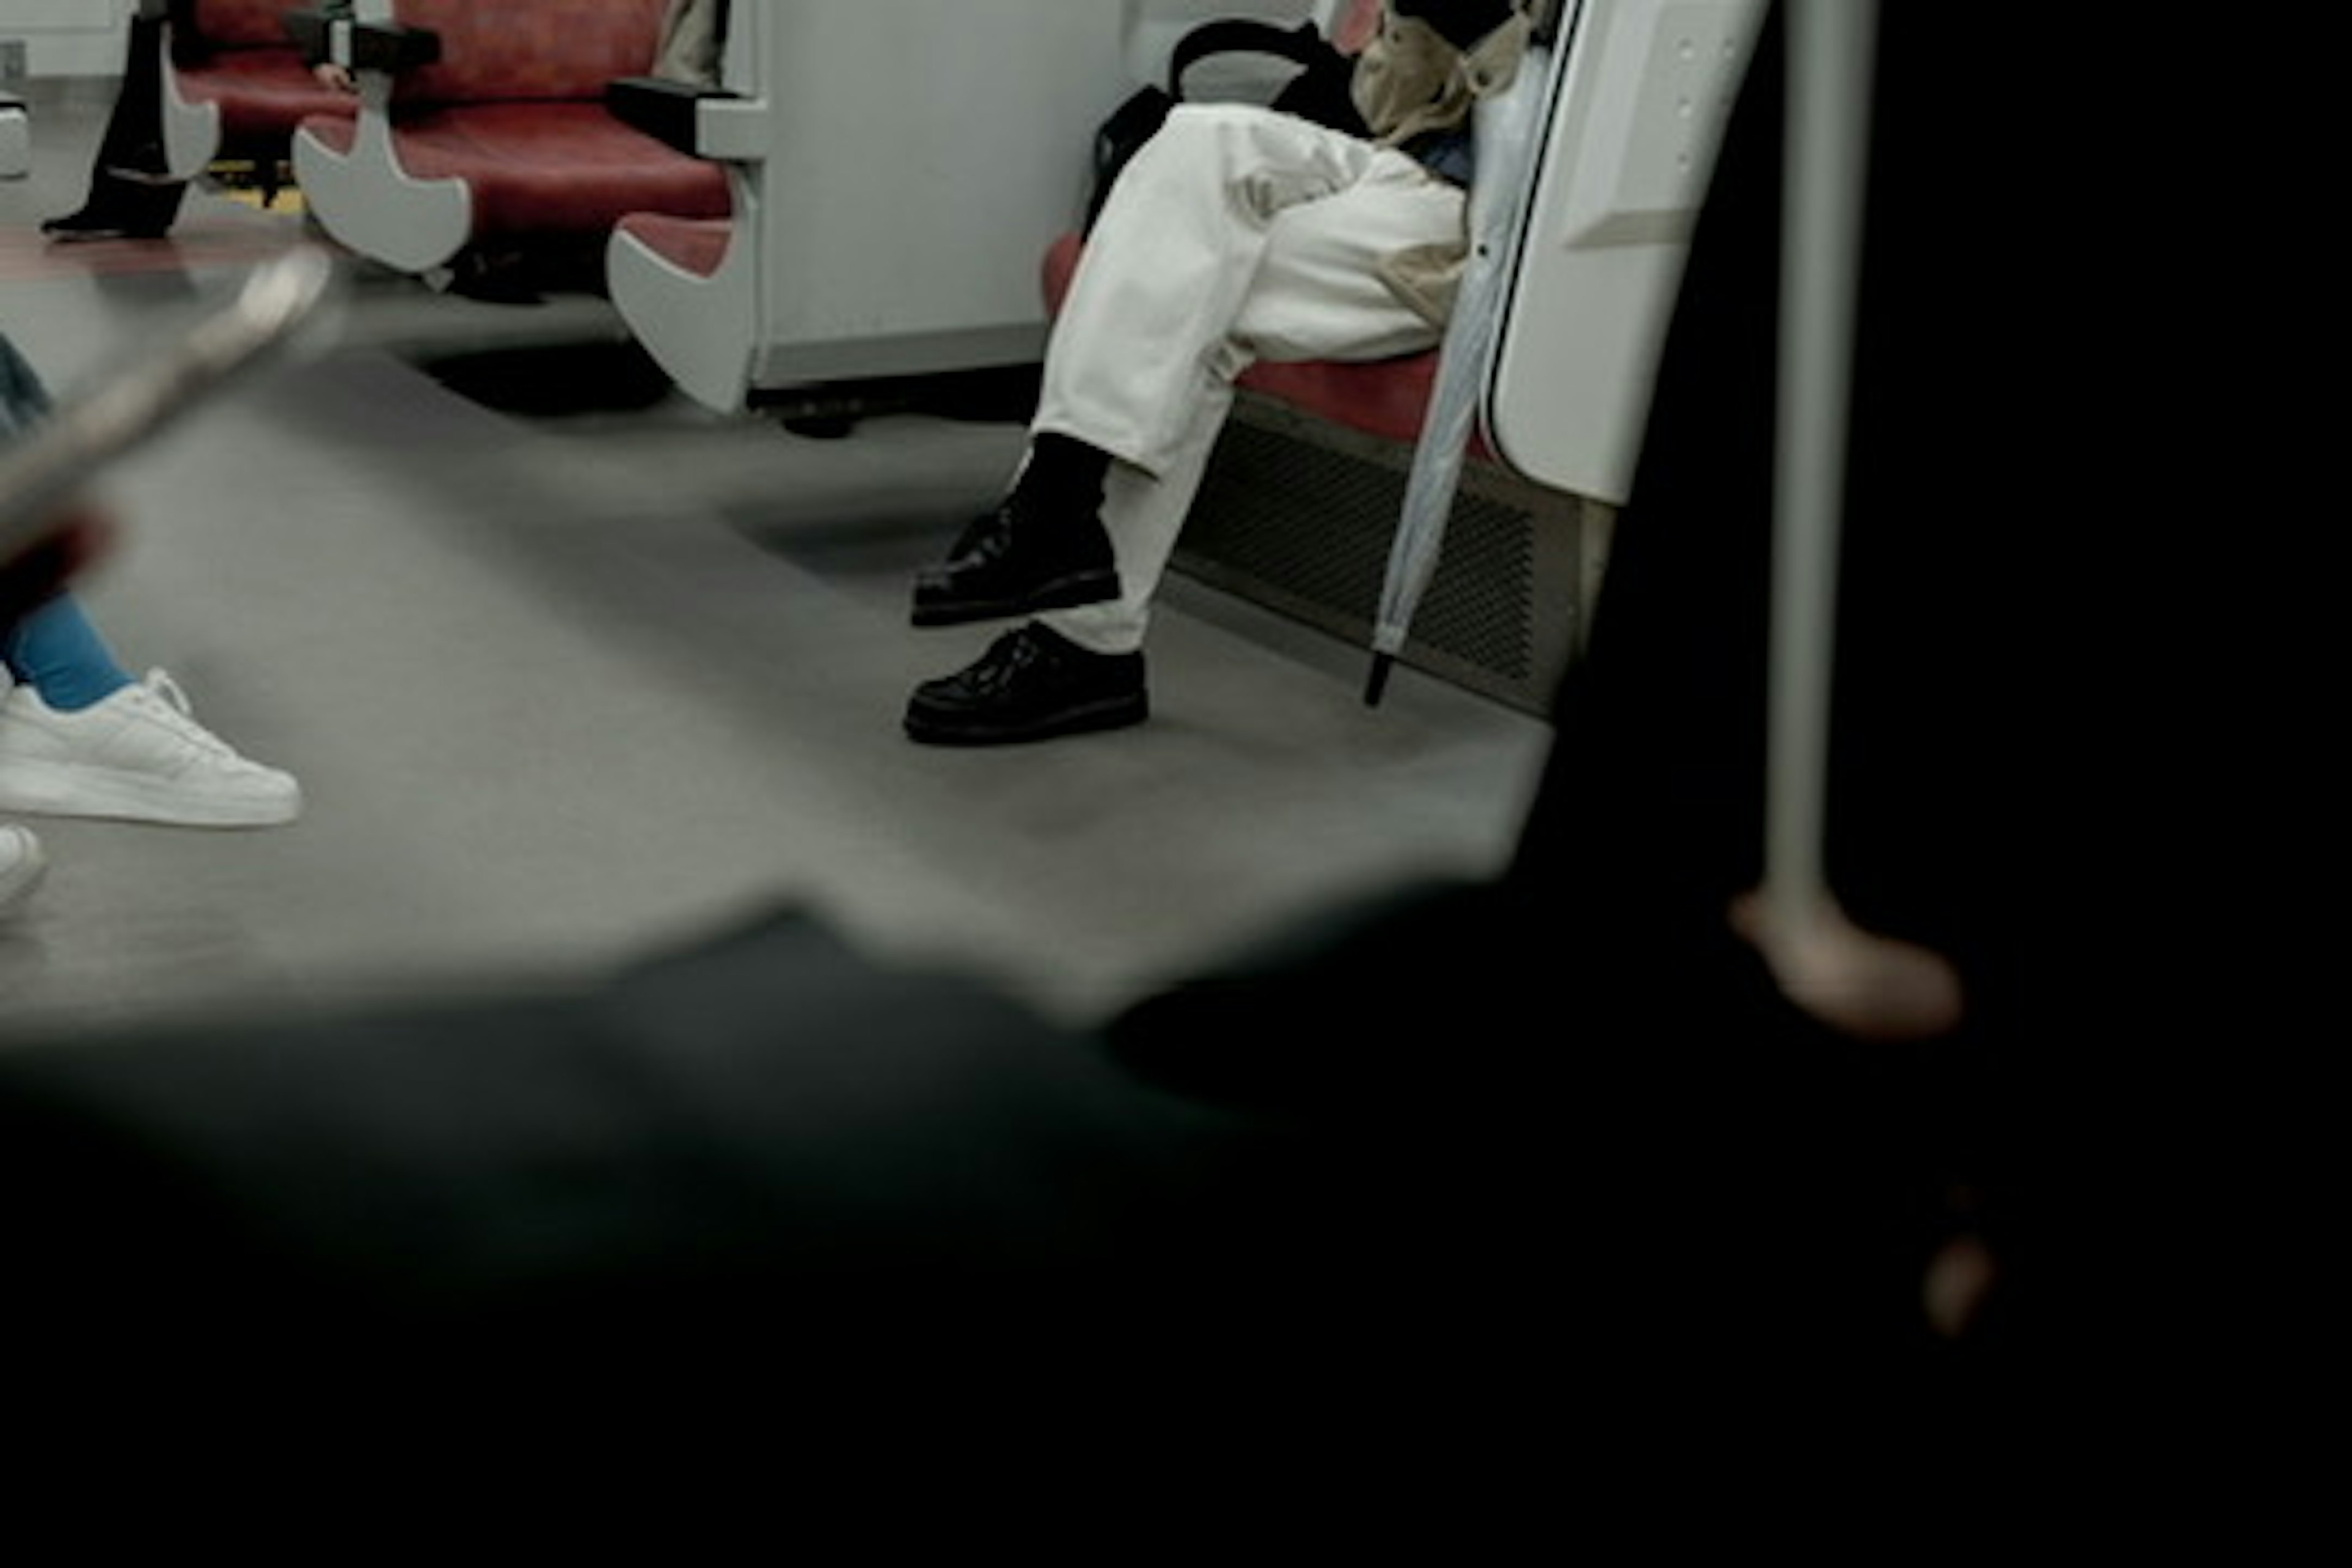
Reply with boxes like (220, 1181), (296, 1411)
(915, 435), (1120, 625)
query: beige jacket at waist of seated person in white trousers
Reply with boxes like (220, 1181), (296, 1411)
(1352, 0), (1531, 326)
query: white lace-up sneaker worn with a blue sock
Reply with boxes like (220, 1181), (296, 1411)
(0, 670), (301, 827)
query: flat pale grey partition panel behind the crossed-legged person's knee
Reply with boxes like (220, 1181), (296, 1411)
(753, 0), (1126, 385)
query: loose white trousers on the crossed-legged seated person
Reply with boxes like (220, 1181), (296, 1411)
(1033, 104), (1463, 654)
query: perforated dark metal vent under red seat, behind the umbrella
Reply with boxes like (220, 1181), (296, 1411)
(1176, 398), (1607, 712)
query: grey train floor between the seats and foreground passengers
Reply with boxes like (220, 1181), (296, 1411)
(0, 85), (1548, 1037)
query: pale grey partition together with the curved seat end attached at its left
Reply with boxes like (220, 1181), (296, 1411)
(607, 0), (1319, 409)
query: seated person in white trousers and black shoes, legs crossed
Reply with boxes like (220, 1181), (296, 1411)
(905, 0), (1526, 745)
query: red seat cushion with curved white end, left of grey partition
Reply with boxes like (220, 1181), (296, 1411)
(303, 104), (731, 238)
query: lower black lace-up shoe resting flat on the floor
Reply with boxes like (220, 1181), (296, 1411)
(905, 623), (1150, 745)
